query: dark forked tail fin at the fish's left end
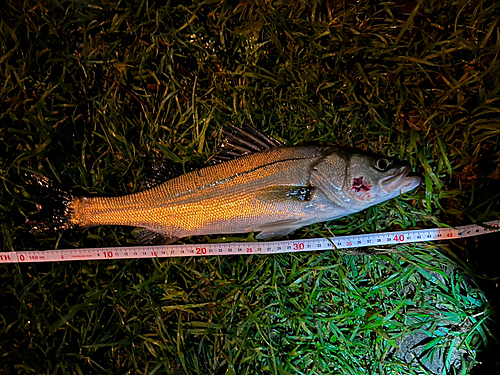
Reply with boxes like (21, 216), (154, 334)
(26, 174), (74, 233)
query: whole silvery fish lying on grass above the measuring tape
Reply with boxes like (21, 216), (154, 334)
(28, 128), (421, 244)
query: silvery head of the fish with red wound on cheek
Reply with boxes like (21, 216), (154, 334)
(342, 153), (422, 207)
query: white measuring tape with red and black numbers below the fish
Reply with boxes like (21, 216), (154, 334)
(0, 220), (500, 263)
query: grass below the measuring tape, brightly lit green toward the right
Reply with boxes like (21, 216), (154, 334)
(3, 245), (490, 374)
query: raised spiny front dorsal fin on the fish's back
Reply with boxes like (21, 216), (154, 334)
(214, 125), (283, 161)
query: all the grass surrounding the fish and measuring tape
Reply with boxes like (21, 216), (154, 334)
(0, 0), (500, 375)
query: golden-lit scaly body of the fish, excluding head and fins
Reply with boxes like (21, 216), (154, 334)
(71, 147), (332, 237)
